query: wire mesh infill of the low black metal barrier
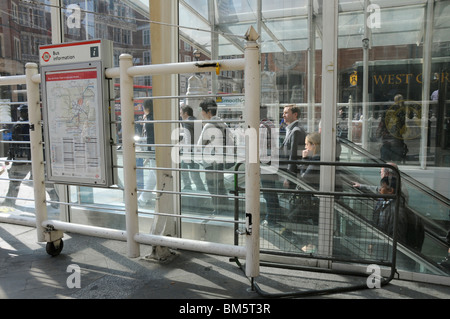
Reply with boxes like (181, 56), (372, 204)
(260, 193), (392, 264)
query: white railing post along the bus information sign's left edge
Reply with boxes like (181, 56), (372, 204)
(25, 63), (47, 242)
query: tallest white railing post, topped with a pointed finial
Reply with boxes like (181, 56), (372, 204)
(244, 27), (261, 277)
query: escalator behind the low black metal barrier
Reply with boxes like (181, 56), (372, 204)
(261, 157), (450, 276)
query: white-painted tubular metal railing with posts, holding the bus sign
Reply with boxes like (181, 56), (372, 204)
(0, 28), (260, 277)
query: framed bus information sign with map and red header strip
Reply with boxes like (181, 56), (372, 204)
(40, 40), (114, 186)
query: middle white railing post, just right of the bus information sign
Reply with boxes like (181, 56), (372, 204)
(119, 54), (140, 257)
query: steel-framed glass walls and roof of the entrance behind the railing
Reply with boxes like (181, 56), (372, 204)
(0, 0), (450, 282)
